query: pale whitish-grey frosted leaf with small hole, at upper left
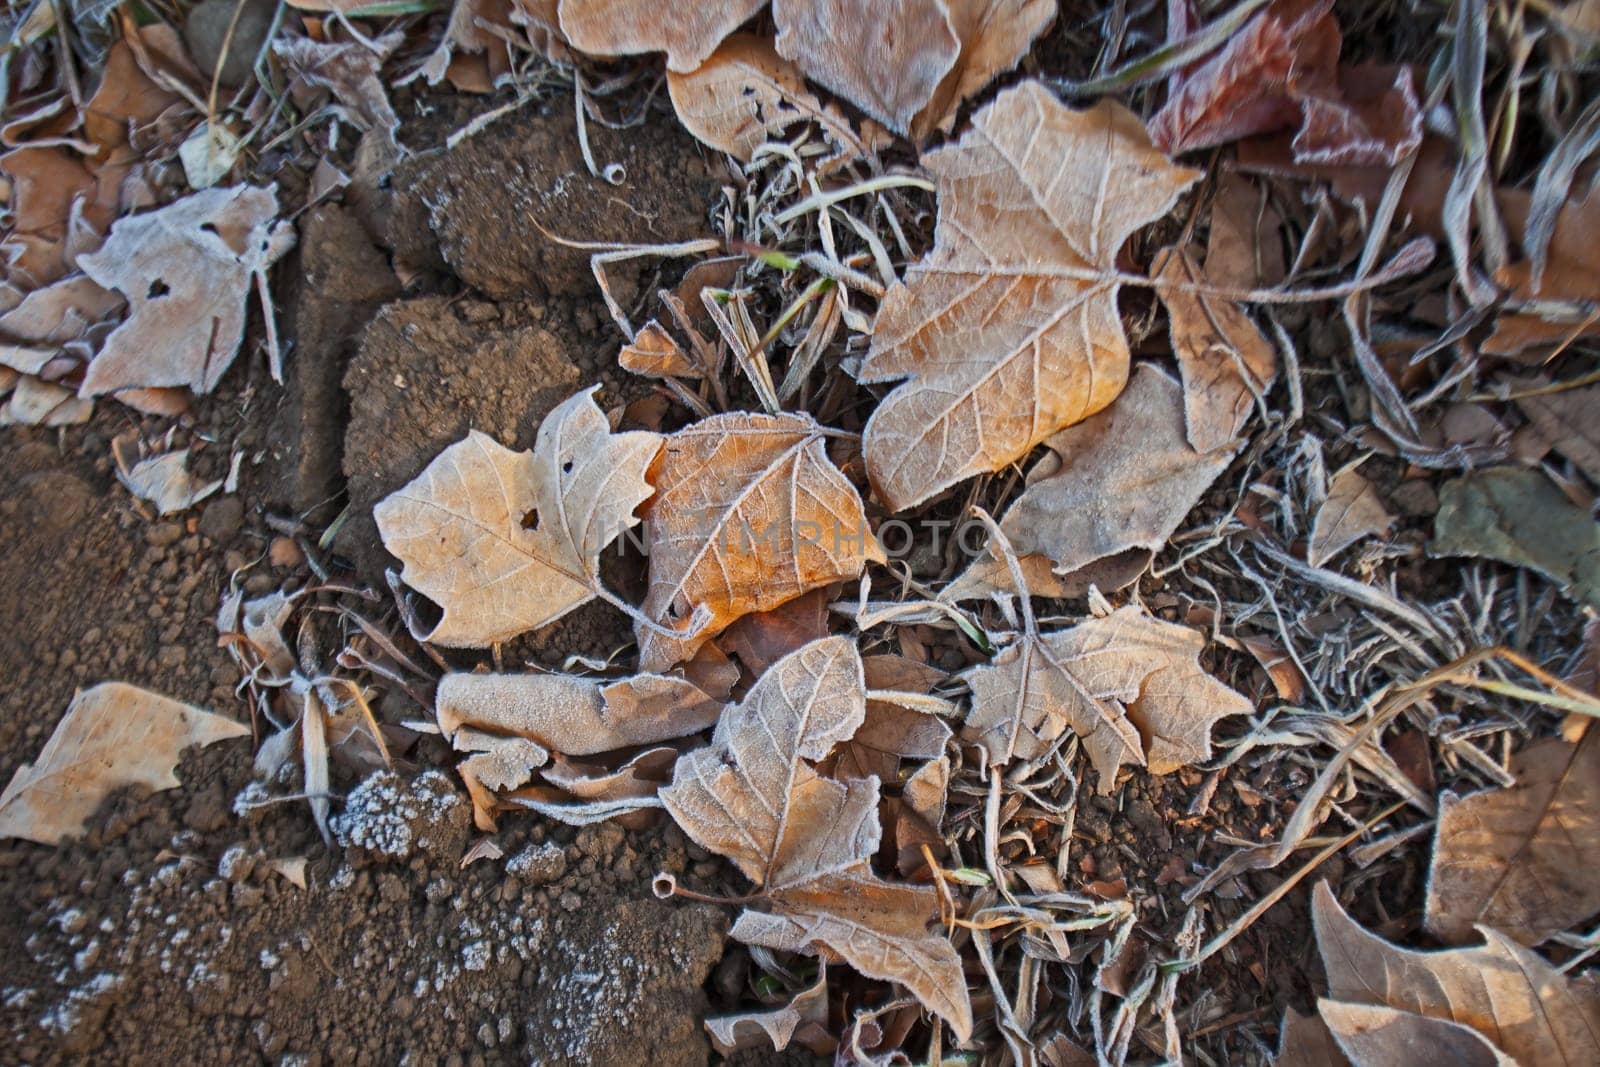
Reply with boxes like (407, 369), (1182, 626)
(78, 186), (294, 397)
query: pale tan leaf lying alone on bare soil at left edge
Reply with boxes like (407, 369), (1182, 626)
(0, 681), (250, 845)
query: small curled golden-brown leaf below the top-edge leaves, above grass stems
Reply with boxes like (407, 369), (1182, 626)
(667, 34), (867, 162)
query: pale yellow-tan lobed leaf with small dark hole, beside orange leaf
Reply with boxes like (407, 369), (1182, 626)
(373, 386), (661, 648)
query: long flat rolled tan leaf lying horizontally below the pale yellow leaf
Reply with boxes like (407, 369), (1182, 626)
(435, 673), (722, 755)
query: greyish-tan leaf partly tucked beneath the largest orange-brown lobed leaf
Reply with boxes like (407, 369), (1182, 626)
(1000, 365), (1237, 585)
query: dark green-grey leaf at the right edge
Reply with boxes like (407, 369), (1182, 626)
(1429, 467), (1600, 608)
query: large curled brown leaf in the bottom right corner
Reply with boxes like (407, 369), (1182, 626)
(1312, 881), (1600, 1064)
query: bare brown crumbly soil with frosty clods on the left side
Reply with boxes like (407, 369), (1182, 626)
(0, 85), (742, 1064)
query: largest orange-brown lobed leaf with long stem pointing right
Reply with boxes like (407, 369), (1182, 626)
(861, 82), (1198, 510)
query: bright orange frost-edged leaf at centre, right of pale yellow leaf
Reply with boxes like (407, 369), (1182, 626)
(634, 413), (883, 670)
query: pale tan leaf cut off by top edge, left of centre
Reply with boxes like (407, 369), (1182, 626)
(560, 0), (766, 74)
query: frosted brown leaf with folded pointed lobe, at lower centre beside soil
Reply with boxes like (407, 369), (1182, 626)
(661, 637), (971, 1040)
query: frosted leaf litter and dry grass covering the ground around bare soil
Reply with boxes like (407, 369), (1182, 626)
(9, 0), (1600, 1064)
